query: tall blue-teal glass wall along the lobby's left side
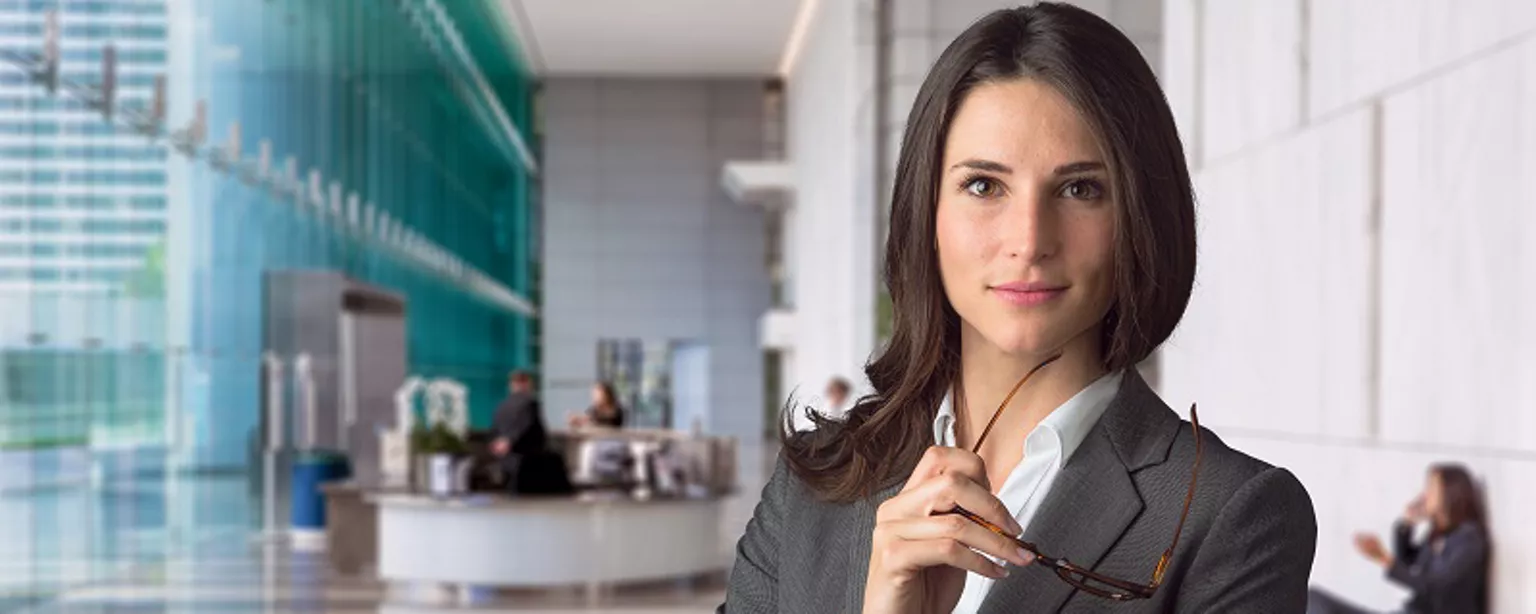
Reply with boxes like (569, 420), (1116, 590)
(0, 0), (539, 600)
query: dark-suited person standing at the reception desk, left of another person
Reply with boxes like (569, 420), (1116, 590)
(490, 371), (571, 493)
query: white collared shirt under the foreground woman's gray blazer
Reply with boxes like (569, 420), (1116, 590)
(934, 371), (1124, 614)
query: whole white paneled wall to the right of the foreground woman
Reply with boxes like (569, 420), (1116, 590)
(1161, 0), (1536, 612)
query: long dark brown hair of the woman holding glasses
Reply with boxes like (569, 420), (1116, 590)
(782, 3), (1195, 502)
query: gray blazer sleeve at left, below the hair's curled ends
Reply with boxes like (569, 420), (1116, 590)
(716, 459), (793, 614)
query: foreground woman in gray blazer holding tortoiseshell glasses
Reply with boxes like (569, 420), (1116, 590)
(722, 3), (1316, 612)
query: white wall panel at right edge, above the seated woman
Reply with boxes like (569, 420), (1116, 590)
(1381, 37), (1536, 451)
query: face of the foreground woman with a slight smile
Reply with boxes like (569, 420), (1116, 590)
(935, 78), (1117, 358)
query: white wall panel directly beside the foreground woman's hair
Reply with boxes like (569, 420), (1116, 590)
(1161, 112), (1372, 436)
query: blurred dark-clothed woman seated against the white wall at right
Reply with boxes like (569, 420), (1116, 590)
(1307, 464), (1491, 614)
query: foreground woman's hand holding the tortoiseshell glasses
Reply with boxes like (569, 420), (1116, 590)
(863, 447), (1034, 614)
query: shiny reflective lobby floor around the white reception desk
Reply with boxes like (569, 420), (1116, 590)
(0, 451), (771, 614)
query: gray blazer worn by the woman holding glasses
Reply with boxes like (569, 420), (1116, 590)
(719, 370), (1318, 614)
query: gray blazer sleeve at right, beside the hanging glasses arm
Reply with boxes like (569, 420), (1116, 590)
(1177, 467), (1318, 614)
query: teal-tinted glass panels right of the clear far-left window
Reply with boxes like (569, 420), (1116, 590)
(176, 0), (536, 465)
